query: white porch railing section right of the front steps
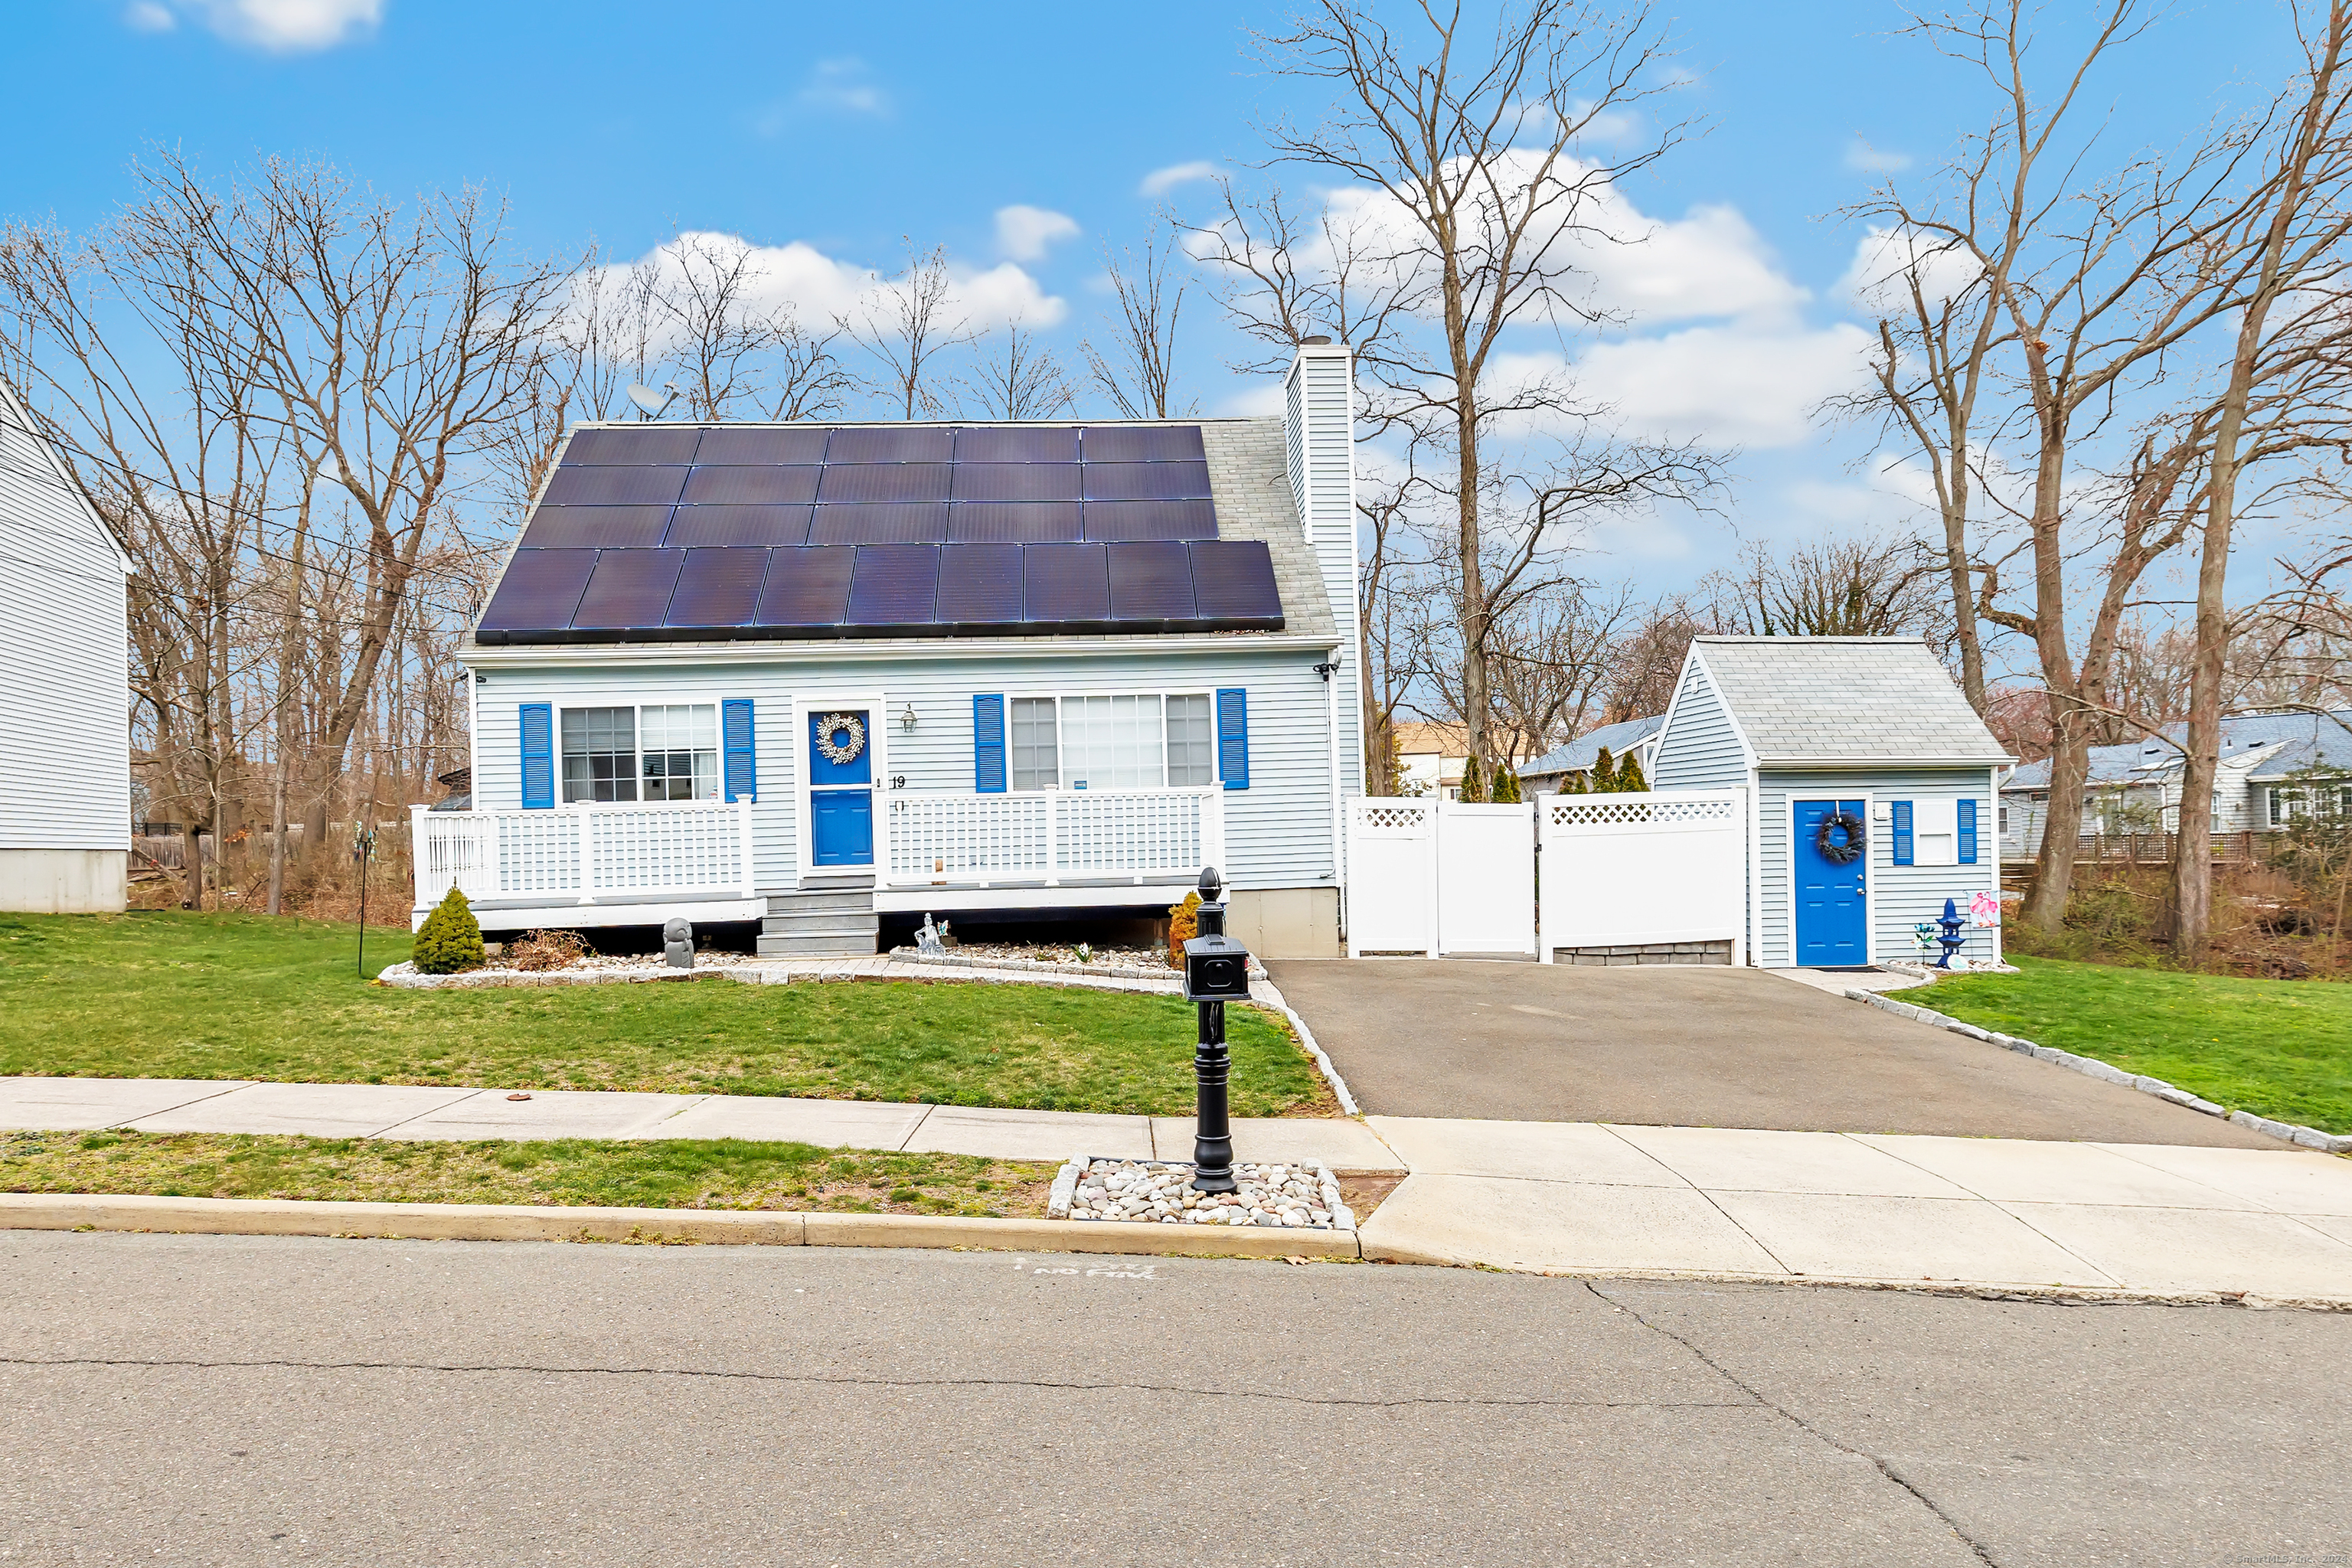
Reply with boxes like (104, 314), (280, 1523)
(877, 790), (1226, 887)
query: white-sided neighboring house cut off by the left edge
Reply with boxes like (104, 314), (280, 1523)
(0, 378), (132, 914)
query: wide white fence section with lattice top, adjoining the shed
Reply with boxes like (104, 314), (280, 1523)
(1540, 790), (1747, 964)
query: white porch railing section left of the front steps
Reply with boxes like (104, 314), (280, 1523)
(410, 799), (753, 910)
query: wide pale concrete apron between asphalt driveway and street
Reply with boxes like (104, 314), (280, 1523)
(1362, 1116), (2352, 1305)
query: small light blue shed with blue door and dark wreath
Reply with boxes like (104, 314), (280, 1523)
(1651, 637), (2016, 969)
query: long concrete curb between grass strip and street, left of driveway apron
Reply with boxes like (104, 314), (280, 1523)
(0, 1192), (1362, 1263)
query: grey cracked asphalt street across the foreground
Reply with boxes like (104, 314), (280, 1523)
(0, 1232), (2352, 1568)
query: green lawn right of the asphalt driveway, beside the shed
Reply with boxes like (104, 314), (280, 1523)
(1929, 957), (2352, 1133)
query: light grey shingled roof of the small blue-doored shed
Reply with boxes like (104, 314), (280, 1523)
(1691, 637), (2008, 764)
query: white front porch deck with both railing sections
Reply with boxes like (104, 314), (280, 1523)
(410, 788), (1226, 929)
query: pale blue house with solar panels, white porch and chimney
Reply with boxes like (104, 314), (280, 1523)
(414, 341), (1364, 957)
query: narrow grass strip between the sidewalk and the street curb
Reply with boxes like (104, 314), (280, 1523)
(0, 1133), (1054, 1220)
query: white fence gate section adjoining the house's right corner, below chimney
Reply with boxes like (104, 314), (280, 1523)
(1348, 797), (1536, 959)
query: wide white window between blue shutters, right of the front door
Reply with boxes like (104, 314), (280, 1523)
(1009, 691), (1216, 790)
